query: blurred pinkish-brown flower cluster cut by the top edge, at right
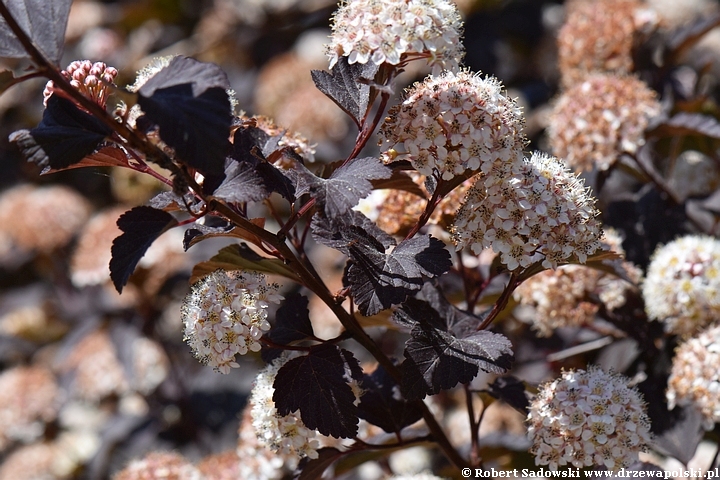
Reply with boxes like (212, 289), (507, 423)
(558, 0), (653, 87)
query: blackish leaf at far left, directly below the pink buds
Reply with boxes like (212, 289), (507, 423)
(10, 95), (111, 171)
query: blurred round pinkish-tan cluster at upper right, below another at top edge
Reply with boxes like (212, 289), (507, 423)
(548, 74), (660, 171)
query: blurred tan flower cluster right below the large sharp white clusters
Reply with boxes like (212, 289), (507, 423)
(515, 229), (642, 337)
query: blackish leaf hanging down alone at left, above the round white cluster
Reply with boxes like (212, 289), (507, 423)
(110, 206), (178, 292)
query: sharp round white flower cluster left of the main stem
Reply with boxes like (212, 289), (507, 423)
(181, 270), (282, 373)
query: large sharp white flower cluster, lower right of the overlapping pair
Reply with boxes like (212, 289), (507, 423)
(453, 152), (602, 270)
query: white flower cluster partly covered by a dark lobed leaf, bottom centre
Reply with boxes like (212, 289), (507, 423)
(250, 353), (320, 463)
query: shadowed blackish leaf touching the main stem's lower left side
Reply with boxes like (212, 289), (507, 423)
(358, 366), (422, 433)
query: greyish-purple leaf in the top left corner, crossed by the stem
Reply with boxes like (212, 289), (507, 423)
(0, 0), (72, 65)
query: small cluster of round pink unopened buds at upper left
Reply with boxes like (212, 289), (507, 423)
(43, 60), (118, 108)
